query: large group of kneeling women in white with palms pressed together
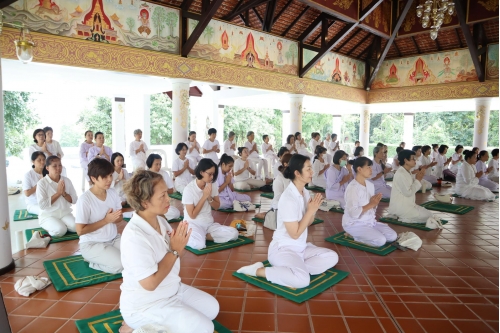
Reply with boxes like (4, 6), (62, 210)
(23, 129), (498, 333)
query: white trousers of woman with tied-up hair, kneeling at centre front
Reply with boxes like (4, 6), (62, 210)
(266, 243), (339, 288)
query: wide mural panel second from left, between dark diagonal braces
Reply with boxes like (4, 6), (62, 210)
(188, 19), (299, 75)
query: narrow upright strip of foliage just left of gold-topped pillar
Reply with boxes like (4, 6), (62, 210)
(150, 94), (172, 145)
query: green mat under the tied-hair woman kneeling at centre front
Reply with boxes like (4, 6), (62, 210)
(233, 260), (349, 303)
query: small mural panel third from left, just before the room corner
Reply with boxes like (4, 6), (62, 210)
(303, 49), (365, 88)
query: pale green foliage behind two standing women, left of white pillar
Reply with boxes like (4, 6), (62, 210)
(76, 97), (112, 146)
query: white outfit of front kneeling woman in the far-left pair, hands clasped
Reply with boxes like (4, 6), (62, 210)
(36, 175), (78, 237)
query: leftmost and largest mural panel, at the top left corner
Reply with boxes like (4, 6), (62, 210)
(3, 0), (179, 53)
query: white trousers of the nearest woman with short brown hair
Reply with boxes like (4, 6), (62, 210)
(123, 283), (219, 333)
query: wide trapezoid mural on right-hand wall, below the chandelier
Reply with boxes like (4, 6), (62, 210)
(371, 49), (478, 89)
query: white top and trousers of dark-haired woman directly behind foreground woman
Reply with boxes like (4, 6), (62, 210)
(75, 188), (123, 274)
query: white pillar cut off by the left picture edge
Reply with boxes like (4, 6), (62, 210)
(0, 47), (15, 275)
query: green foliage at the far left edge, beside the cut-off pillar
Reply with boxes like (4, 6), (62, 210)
(3, 91), (39, 156)
